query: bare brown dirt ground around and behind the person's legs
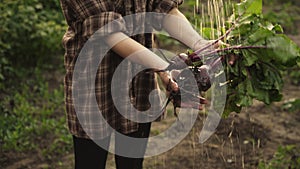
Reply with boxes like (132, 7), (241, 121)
(0, 36), (300, 169)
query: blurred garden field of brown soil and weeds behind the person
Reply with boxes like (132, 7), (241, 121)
(0, 0), (300, 169)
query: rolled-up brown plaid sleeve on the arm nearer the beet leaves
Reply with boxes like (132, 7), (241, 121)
(152, 0), (183, 30)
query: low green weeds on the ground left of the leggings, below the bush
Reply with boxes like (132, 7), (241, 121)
(0, 69), (71, 159)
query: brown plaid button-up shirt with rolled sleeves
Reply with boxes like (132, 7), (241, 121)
(60, 0), (182, 139)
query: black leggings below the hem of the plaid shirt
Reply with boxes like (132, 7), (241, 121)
(73, 123), (151, 169)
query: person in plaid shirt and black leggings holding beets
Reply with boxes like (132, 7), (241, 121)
(60, 0), (213, 169)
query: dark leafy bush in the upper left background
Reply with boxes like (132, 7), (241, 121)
(0, 0), (66, 70)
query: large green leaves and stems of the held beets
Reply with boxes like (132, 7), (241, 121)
(176, 0), (300, 115)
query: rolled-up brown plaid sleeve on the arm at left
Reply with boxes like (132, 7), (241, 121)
(61, 0), (126, 39)
